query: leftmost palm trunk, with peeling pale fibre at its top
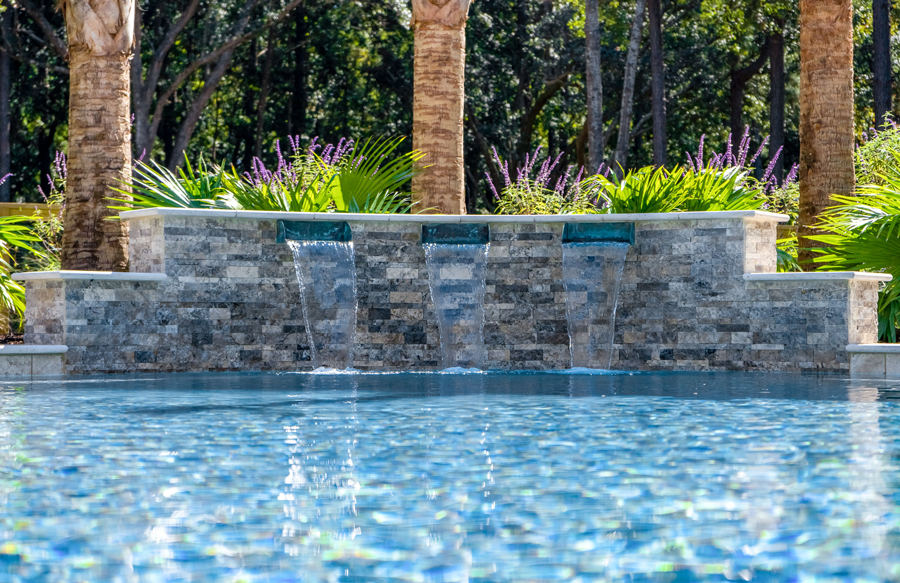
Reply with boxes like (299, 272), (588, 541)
(61, 0), (135, 271)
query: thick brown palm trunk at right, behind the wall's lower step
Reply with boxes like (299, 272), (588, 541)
(798, 0), (855, 270)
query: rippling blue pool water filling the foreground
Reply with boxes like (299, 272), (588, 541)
(0, 373), (900, 582)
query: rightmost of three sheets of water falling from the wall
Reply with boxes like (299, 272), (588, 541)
(563, 242), (630, 369)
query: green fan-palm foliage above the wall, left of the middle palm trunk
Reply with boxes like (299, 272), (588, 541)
(111, 137), (424, 213)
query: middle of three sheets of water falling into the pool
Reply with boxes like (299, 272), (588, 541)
(423, 243), (488, 368)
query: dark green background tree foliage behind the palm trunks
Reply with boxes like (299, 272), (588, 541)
(2, 0), (900, 212)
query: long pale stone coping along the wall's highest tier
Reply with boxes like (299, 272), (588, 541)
(119, 208), (790, 224)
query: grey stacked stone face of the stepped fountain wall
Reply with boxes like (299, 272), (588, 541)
(17, 210), (878, 373)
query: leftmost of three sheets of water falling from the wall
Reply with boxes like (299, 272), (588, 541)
(287, 241), (357, 369)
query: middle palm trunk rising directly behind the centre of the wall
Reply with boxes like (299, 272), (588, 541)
(412, 0), (470, 215)
